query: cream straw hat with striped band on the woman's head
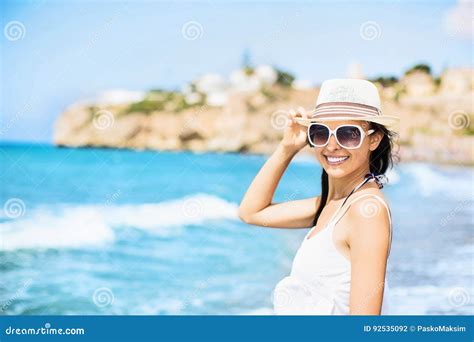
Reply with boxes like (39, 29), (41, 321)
(295, 78), (400, 131)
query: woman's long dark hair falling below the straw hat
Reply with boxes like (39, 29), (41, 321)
(313, 122), (397, 227)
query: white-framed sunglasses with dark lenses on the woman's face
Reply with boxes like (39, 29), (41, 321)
(308, 123), (375, 150)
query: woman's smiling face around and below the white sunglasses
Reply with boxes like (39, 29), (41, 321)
(315, 120), (382, 178)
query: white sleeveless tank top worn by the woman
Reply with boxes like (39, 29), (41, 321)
(273, 179), (392, 315)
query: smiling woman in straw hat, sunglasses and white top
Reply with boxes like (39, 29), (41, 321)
(239, 79), (398, 315)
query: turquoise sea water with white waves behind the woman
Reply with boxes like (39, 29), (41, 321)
(0, 145), (474, 315)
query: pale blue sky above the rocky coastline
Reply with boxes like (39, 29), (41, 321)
(0, 0), (473, 142)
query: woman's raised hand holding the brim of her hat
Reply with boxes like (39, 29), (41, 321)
(280, 107), (309, 154)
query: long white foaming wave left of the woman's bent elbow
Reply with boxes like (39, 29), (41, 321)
(0, 194), (237, 251)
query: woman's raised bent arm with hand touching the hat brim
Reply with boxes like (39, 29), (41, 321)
(239, 108), (318, 228)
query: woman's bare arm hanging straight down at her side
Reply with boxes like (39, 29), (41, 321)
(346, 199), (390, 315)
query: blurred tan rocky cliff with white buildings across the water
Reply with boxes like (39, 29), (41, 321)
(54, 67), (474, 164)
